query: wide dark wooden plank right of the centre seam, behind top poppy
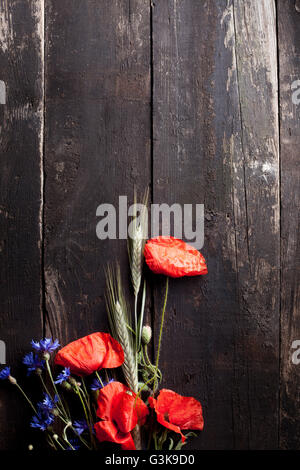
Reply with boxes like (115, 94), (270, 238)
(153, 0), (279, 449)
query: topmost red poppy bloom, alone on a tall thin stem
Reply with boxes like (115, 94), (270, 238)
(144, 237), (207, 277)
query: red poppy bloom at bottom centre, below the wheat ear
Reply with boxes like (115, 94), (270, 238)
(94, 382), (149, 450)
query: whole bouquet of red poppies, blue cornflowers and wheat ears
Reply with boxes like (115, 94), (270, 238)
(0, 194), (207, 450)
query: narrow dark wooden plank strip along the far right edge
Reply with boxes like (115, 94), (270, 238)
(278, 0), (300, 449)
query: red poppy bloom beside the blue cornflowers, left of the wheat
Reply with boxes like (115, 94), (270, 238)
(55, 333), (124, 376)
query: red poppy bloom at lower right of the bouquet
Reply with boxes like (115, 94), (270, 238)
(149, 389), (204, 442)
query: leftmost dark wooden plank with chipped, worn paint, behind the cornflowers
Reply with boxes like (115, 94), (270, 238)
(0, 0), (43, 450)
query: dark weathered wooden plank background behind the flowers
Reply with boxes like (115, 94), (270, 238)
(0, 0), (300, 449)
